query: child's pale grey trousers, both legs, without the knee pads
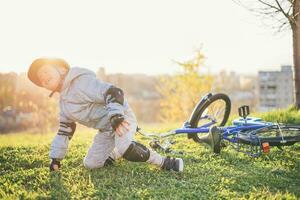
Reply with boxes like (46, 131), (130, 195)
(83, 108), (164, 169)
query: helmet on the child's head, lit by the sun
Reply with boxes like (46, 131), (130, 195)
(27, 58), (70, 87)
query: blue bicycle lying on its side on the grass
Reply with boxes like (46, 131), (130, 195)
(138, 93), (300, 157)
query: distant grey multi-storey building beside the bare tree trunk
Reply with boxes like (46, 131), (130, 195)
(258, 65), (294, 111)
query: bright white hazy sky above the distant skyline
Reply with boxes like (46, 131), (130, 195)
(0, 0), (292, 74)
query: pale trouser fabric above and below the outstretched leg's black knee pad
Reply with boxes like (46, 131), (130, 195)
(111, 109), (164, 167)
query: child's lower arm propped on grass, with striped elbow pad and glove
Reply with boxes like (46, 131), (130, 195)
(49, 113), (76, 171)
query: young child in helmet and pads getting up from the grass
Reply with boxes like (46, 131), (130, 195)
(28, 58), (183, 172)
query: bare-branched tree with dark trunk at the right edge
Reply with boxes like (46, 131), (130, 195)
(234, 0), (300, 109)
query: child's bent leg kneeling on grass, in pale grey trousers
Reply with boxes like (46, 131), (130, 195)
(83, 131), (115, 169)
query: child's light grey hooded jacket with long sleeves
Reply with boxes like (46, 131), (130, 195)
(49, 67), (135, 160)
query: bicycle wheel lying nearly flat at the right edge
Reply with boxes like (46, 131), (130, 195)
(237, 124), (300, 146)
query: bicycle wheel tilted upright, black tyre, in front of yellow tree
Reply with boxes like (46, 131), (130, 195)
(189, 93), (231, 143)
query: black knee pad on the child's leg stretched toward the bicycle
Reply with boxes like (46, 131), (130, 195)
(123, 141), (150, 162)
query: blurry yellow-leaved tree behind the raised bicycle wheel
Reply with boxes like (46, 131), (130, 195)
(157, 50), (213, 122)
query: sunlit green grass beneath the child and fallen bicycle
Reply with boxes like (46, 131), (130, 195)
(0, 110), (300, 199)
